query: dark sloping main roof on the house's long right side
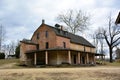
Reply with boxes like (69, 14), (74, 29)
(45, 24), (95, 48)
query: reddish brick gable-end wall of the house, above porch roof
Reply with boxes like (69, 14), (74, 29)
(32, 24), (56, 49)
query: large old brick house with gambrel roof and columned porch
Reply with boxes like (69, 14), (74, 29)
(20, 20), (95, 65)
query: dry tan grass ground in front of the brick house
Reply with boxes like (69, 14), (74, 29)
(0, 58), (120, 80)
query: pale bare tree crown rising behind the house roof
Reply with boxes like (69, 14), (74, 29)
(57, 10), (90, 34)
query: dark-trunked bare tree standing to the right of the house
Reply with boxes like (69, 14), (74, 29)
(102, 16), (120, 62)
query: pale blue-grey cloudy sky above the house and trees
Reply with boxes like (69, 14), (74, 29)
(0, 0), (120, 42)
